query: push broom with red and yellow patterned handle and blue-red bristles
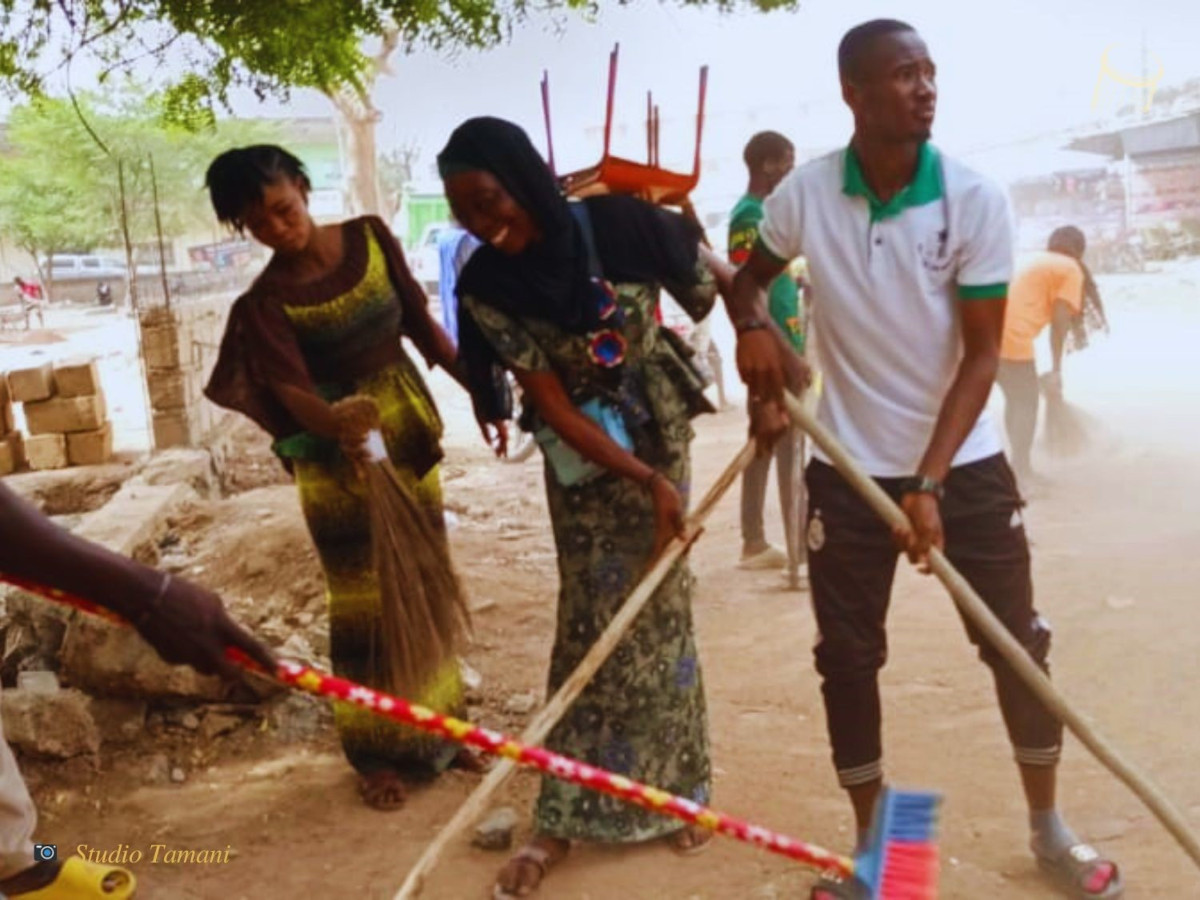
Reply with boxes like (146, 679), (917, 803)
(0, 564), (938, 900)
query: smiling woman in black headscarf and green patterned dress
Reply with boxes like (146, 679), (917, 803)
(438, 119), (732, 898)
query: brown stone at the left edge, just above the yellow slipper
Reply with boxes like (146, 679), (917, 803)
(0, 688), (100, 760)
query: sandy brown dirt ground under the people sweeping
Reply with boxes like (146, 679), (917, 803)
(9, 264), (1200, 900)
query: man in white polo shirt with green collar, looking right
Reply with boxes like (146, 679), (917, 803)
(731, 19), (1122, 898)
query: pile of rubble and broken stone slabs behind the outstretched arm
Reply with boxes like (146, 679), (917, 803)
(0, 450), (331, 784)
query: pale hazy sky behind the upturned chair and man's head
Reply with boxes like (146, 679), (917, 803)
(2, 0), (1200, 199)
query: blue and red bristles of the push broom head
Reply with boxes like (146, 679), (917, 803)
(854, 788), (942, 900)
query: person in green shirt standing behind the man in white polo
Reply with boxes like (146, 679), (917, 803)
(728, 131), (804, 587)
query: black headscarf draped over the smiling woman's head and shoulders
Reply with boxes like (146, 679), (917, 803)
(438, 116), (702, 418)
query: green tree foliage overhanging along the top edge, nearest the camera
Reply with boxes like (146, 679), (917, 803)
(0, 0), (798, 124)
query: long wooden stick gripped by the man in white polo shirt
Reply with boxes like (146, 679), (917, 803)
(786, 395), (1200, 866)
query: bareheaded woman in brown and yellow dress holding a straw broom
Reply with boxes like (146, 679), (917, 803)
(205, 145), (489, 809)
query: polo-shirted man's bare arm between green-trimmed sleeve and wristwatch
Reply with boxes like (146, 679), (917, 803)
(918, 298), (1006, 481)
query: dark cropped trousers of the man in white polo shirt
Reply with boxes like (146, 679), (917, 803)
(806, 454), (1062, 787)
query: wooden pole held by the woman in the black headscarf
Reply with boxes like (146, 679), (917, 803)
(392, 443), (755, 900)
